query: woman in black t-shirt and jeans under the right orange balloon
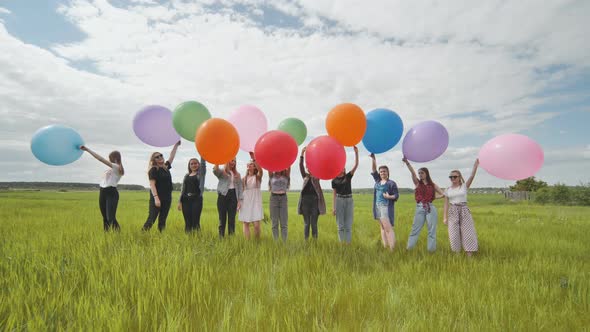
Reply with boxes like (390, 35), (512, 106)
(332, 146), (359, 243)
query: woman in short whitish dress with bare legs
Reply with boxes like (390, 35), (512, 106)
(239, 152), (264, 239)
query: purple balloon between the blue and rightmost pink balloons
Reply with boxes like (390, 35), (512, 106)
(402, 121), (449, 163)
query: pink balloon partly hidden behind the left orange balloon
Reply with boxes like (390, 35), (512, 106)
(227, 105), (268, 152)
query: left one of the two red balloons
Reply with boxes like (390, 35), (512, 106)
(254, 130), (297, 172)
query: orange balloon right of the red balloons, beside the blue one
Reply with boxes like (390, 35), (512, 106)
(326, 104), (367, 146)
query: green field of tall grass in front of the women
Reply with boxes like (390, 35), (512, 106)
(0, 192), (590, 331)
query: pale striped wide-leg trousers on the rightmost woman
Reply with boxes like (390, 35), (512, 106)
(447, 203), (479, 252)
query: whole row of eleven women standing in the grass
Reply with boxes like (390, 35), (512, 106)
(80, 141), (479, 255)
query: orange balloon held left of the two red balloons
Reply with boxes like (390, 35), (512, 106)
(195, 118), (240, 165)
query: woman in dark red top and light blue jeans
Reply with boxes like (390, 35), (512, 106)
(402, 157), (444, 252)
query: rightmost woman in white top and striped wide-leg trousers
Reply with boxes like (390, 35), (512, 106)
(443, 159), (479, 256)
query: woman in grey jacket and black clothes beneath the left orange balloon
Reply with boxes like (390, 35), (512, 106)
(213, 159), (243, 238)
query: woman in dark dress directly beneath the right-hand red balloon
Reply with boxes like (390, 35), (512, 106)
(297, 147), (326, 240)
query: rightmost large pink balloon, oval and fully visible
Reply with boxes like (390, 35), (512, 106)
(479, 134), (544, 180)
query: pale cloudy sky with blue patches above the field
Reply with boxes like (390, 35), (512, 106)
(0, 0), (590, 188)
